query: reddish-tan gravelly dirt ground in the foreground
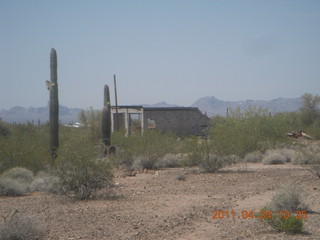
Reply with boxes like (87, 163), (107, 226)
(0, 163), (320, 240)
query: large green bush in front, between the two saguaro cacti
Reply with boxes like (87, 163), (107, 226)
(55, 132), (113, 200)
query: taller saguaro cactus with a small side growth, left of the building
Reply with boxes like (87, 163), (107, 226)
(47, 48), (59, 159)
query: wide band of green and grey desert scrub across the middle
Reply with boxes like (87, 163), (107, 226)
(0, 94), (320, 202)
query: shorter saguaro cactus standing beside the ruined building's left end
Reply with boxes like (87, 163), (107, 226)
(102, 85), (111, 154)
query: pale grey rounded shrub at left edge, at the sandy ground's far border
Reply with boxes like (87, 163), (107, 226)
(0, 168), (33, 196)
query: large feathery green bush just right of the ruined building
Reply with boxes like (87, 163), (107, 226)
(209, 108), (290, 157)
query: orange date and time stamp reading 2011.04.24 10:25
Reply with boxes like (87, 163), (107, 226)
(212, 210), (308, 219)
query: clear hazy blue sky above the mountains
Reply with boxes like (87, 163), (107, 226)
(0, 0), (320, 109)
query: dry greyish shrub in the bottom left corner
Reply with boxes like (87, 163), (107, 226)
(0, 212), (43, 240)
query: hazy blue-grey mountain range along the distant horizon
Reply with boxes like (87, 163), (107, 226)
(0, 97), (301, 124)
